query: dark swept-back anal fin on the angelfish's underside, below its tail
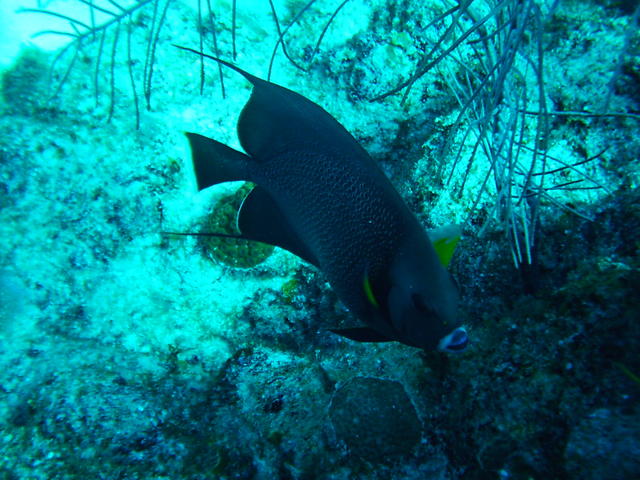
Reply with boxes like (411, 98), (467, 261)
(238, 187), (318, 267)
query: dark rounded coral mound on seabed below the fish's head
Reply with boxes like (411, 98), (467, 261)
(330, 377), (422, 463)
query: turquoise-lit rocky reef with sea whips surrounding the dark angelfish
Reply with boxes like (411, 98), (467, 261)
(0, 0), (640, 480)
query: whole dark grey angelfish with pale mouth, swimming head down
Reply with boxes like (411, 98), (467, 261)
(172, 47), (468, 351)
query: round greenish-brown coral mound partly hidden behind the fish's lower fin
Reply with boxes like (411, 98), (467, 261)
(200, 183), (274, 268)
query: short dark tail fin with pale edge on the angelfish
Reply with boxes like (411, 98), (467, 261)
(186, 133), (251, 190)
